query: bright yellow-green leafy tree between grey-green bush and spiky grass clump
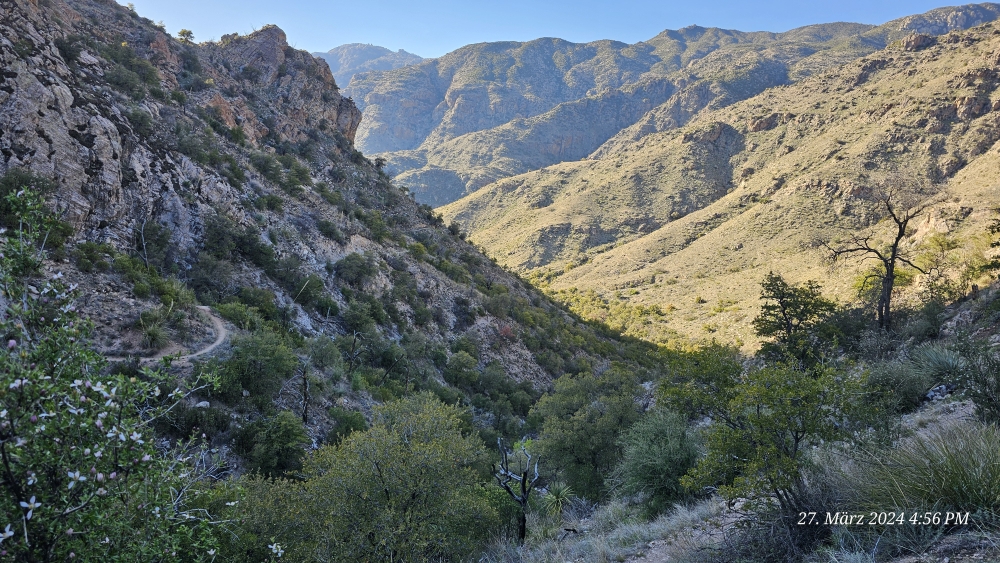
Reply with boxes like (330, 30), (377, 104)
(660, 362), (860, 512)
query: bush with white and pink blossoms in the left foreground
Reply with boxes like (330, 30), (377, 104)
(0, 191), (216, 563)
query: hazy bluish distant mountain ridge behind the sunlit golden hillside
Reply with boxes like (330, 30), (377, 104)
(345, 4), (1000, 205)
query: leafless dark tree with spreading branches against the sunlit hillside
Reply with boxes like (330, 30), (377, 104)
(822, 181), (932, 329)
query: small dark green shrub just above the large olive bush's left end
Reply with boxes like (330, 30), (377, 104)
(233, 411), (310, 478)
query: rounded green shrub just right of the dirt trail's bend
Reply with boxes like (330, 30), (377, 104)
(219, 330), (299, 410)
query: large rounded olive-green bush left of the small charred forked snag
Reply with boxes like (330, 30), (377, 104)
(241, 394), (498, 562)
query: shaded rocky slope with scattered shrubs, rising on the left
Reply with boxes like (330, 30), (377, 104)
(0, 0), (668, 442)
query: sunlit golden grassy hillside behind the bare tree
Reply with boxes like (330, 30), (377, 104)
(443, 19), (1000, 344)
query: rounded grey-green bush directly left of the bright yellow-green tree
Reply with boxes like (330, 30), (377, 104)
(615, 408), (698, 515)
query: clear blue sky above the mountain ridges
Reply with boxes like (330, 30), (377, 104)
(122, 0), (960, 57)
